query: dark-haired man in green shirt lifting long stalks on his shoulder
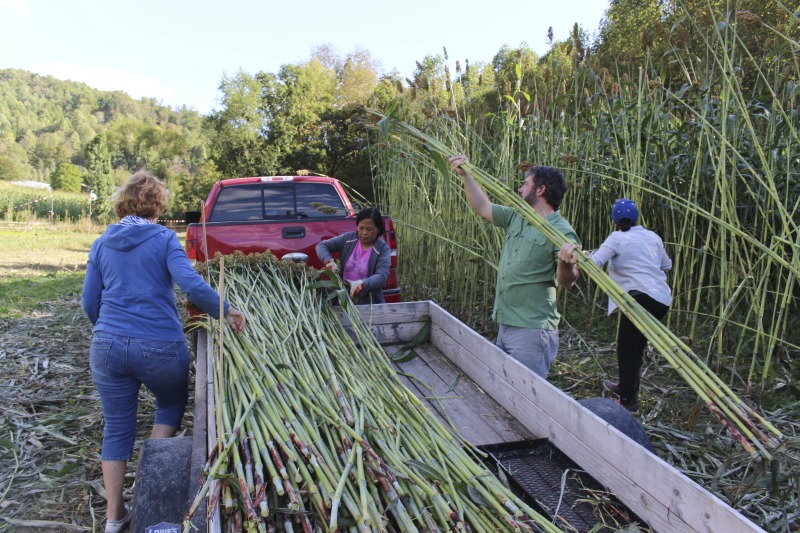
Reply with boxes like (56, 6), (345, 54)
(448, 155), (580, 378)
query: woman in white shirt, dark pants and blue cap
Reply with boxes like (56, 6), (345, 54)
(589, 198), (672, 412)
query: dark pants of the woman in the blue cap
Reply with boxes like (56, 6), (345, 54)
(617, 291), (669, 405)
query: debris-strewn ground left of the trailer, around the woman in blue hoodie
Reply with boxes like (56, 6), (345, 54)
(0, 295), (191, 532)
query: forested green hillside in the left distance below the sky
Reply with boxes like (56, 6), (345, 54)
(0, 69), (208, 218)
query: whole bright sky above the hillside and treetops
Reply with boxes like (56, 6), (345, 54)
(0, 0), (609, 113)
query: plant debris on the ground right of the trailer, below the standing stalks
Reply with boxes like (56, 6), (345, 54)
(548, 331), (800, 532)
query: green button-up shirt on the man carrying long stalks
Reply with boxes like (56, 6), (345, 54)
(492, 204), (580, 330)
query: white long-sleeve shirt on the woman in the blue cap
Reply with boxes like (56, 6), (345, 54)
(589, 226), (672, 315)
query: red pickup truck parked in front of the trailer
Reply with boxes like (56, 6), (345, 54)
(186, 176), (400, 303)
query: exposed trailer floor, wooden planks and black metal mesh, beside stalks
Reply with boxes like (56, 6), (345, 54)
(384, 343), (647, 532)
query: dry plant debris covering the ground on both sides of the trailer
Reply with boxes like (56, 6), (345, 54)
(0, 295), (800, 533)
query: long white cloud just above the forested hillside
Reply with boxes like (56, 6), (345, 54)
(29, 61), (172, 101)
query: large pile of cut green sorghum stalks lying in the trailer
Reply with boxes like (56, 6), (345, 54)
(184, 250), (560, 532)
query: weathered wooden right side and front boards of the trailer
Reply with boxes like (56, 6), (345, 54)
(350, 302), (762, 533)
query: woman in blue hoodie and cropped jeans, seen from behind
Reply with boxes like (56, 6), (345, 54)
(81, 172), (245, 533)
